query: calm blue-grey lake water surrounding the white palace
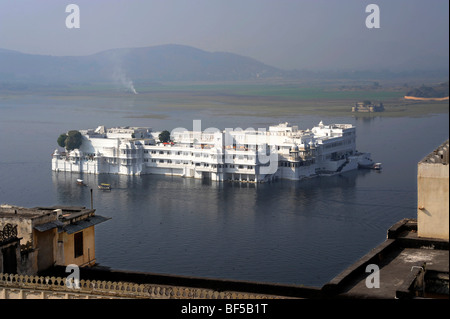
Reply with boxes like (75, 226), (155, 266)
(0, 95), (449, 287)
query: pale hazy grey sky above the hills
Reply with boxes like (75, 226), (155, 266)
(0, 0), (449, 69)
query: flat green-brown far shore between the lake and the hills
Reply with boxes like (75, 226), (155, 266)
(0, 81), (449, 120)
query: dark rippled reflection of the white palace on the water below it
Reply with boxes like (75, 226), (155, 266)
(52, 170), (368, 219)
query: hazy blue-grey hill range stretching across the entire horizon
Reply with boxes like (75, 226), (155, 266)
(0, 44), (448, 91)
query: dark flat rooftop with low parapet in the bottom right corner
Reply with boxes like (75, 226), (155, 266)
(323, 219), (449, 299)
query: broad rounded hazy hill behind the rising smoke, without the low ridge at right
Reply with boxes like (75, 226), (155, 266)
(0, 45), (284, 83)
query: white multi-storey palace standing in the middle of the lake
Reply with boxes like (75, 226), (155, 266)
(52, 121), (373, 182)
